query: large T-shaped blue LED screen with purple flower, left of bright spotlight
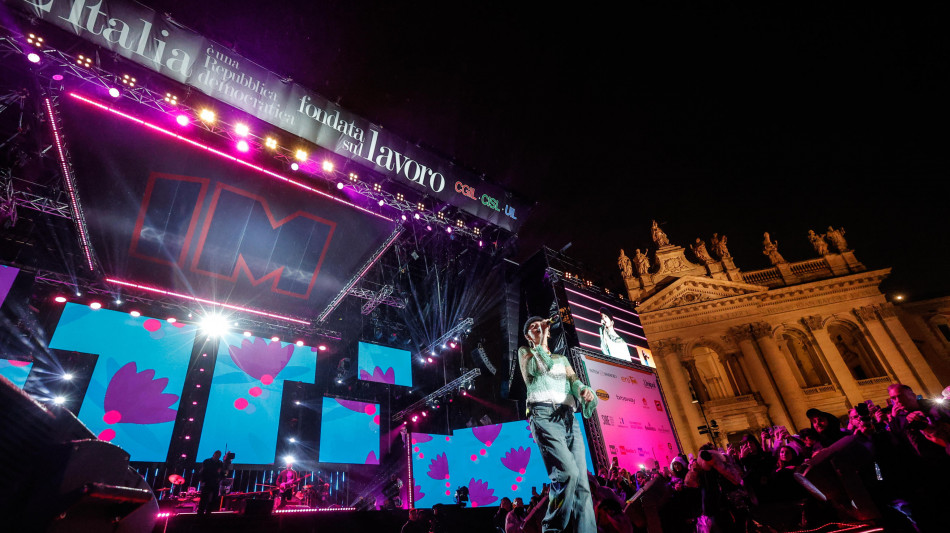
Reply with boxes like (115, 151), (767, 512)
(49, 303), (195, 462)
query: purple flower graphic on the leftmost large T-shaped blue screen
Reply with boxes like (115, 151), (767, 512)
(102, 361), (178, 424)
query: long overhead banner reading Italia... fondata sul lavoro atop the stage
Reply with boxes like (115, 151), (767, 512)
(4, 0), (527, 232)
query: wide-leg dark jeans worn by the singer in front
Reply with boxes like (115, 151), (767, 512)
(530, 404), (597, 533)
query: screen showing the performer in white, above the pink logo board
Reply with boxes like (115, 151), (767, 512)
(564, 286), (656, 368)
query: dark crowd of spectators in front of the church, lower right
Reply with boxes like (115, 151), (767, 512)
(403, 383), (950, 533)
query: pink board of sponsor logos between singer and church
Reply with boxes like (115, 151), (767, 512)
(585, 357), (680, 472)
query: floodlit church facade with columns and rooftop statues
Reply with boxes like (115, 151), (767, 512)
(620, 223), (943, 451)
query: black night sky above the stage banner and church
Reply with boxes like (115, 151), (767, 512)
(144, 0), (950, 299)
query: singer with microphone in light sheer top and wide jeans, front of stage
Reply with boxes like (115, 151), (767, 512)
(518, 316), (597, 533)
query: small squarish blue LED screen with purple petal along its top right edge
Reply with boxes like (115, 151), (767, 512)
(320, 397), (379, 465)
